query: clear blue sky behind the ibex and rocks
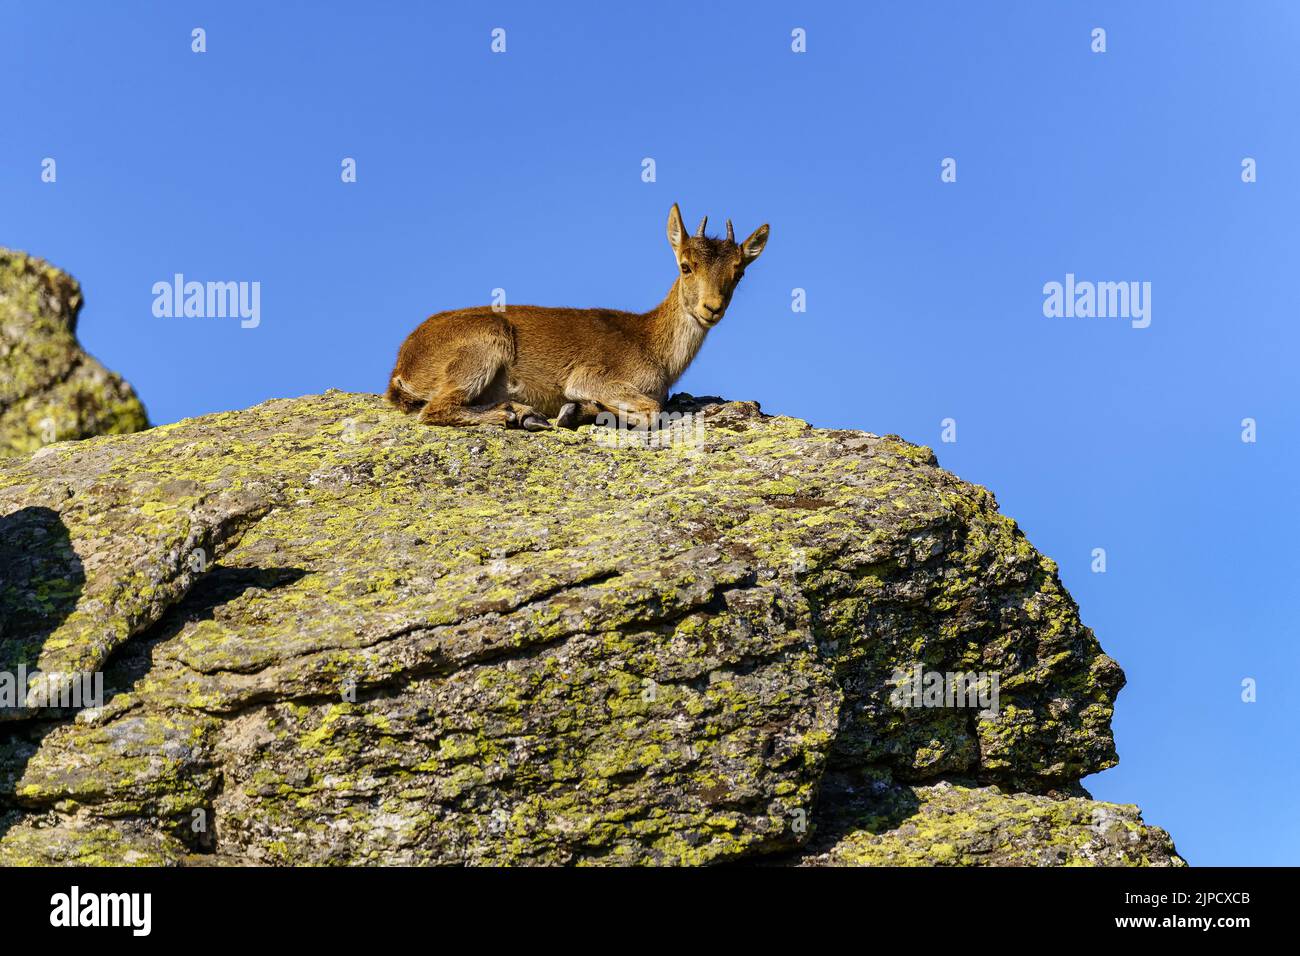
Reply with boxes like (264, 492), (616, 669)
(0, 0), (1300, 864)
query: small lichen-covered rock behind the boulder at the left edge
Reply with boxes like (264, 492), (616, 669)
(0, 247), (148, 457)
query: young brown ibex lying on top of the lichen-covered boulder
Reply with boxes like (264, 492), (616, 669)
(387, 203), (767, 431)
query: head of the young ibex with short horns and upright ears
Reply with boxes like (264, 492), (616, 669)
(668, 203), (767, 329)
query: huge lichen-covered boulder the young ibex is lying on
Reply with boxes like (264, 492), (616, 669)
(0, 392), (1177, 864)
